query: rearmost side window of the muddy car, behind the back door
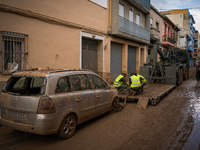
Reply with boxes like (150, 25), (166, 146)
(55, 77), (71, 93)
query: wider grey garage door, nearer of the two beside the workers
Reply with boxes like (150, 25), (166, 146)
(110, 42), (122, 83)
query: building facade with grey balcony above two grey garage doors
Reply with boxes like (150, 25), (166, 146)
(108, 0), (150, 82)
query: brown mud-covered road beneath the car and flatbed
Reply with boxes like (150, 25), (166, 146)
(0, 68), (200, 150)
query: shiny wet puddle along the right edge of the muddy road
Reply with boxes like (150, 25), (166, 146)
(168, 79), (200, 150)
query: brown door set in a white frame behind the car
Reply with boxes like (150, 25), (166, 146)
(82, 38), (97, 73)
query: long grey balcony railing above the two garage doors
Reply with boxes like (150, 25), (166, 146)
(119, 16), (150, 41)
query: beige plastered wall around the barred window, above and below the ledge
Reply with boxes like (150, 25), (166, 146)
(0, 0), (107, 70)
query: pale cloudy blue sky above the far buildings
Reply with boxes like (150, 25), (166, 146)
(151, 0), (200, 32)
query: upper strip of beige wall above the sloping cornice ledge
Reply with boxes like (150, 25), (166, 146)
(0, 0), (107, 31)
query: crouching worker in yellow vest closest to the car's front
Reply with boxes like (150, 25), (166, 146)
(114, 73), (128, 92)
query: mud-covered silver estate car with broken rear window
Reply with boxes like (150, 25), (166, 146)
(0, 70), (117, 138)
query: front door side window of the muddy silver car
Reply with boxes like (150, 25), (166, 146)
(90, 75), (107, 89)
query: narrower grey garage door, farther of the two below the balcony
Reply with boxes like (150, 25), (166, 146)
(128, 46), (136, 77)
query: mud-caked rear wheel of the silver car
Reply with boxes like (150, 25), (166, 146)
(57, 114), (76, 139)
